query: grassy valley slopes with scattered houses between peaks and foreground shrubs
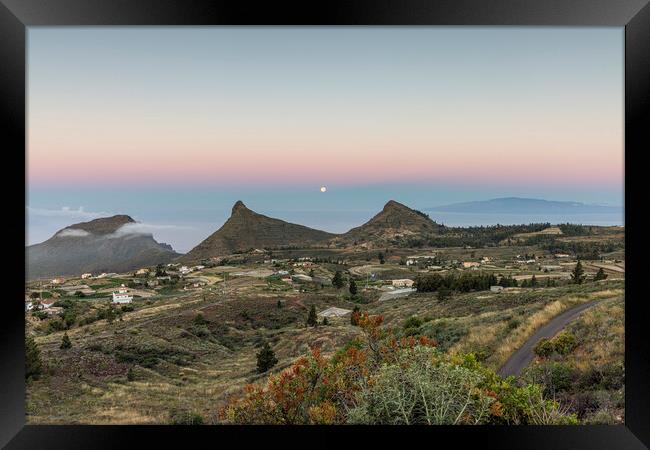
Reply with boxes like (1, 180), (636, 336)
(25, 223), (625, 423)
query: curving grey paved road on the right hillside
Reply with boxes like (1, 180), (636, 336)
(497, 300), (602, 377)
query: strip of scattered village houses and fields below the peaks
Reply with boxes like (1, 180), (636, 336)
(25, 241), (625, 317)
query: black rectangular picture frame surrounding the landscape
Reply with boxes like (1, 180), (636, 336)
(0, 0), (650, 449)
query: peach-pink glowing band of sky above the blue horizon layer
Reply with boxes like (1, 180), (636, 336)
(27, 118), (623, 186)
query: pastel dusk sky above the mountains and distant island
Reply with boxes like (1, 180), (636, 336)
(26, 27), (624, 251)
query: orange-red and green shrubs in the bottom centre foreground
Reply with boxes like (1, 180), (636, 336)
(220, 314), (578, 425)
